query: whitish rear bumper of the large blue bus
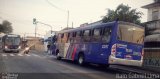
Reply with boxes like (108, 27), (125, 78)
(109, 56), (142, 66)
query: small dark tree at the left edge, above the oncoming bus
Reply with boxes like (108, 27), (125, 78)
(0, 20), (13, 33)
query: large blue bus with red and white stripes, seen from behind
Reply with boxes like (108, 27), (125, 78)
(54, 21), (144, 67)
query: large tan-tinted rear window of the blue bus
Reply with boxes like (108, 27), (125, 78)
(118, 24), (144, 44)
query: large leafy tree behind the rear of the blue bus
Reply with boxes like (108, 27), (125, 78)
(102, 4), (143, 24)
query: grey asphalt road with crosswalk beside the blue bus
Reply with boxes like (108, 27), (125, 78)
(0, 52), (159, 79)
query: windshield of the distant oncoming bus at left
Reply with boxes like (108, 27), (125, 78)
(6, 37), (20, 45)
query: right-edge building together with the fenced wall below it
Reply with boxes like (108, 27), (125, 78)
(142, 0), (160, 72)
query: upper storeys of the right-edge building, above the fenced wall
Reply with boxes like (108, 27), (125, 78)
(142, 0), (160, 47)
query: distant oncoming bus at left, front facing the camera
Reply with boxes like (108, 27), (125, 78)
(2, 34), (21, 53)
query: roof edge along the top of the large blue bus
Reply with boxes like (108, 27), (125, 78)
(58, 21), (144, 33)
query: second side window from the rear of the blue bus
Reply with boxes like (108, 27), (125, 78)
(92, 28), (101, 42)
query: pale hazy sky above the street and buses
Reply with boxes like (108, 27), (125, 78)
(0, 0), (153, 35)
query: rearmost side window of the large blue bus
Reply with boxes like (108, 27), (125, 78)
(102, 27), (111, 43)
